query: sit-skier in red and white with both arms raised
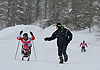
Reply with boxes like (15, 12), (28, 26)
(17, 30), (35, 61)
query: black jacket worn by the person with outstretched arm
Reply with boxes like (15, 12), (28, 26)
(48, 27), (72, 47)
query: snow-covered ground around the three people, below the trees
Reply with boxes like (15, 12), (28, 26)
(0, 25), (100, 70)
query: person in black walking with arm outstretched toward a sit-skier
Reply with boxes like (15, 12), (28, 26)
(44, 23), (72, 63)
